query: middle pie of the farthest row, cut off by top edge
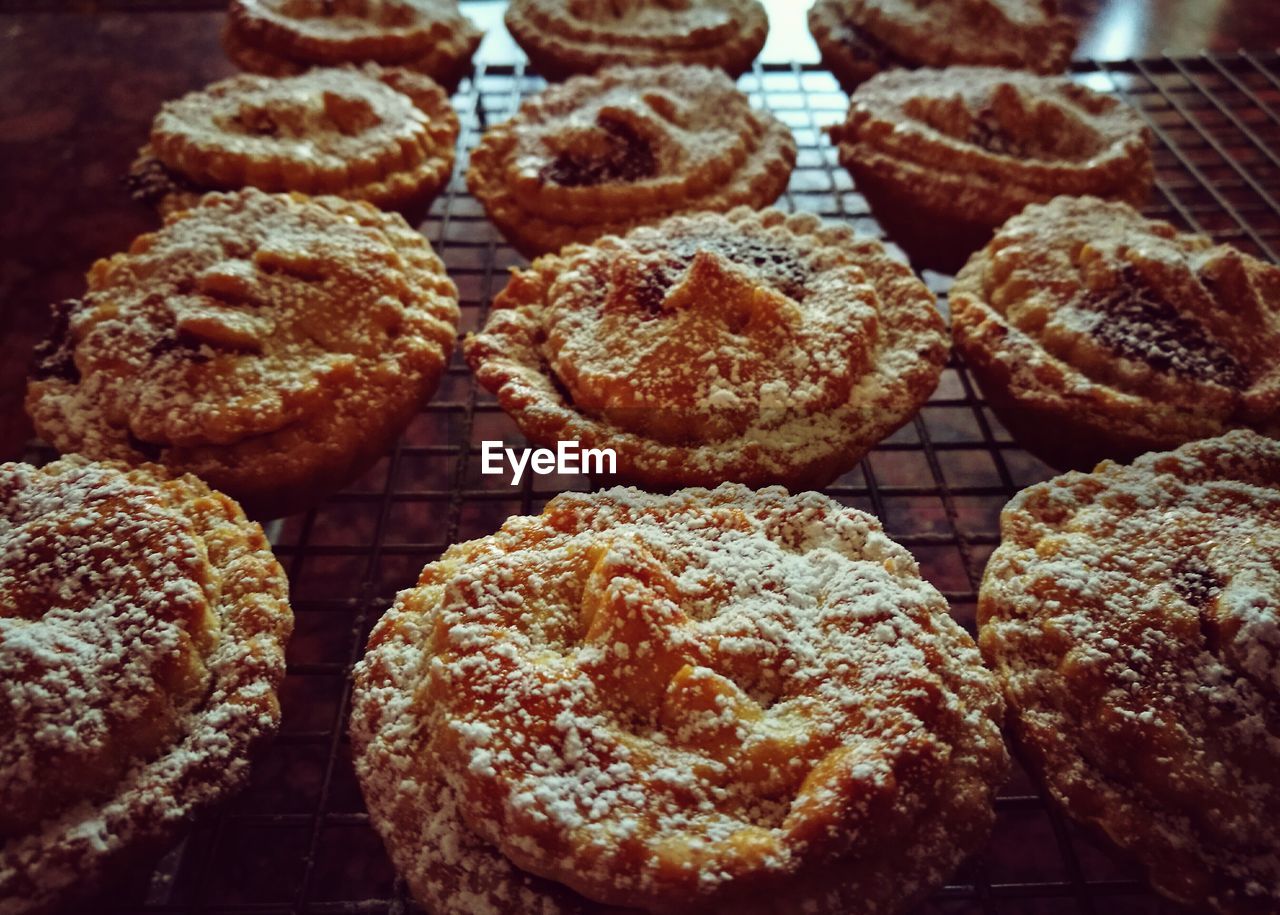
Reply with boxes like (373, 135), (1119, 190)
(506, 0), (769, 79)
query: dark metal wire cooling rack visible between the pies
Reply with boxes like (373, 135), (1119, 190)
(40, 54), (1280, 915)
